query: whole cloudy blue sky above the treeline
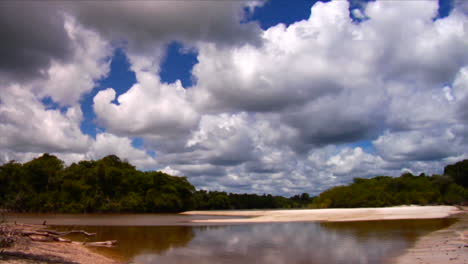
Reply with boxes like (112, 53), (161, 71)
(0, 0), (468, 196)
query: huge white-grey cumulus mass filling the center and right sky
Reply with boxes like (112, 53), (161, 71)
(87, 1), (468, 193)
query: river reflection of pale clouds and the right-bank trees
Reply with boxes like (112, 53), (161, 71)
(133, 220), (449, 264)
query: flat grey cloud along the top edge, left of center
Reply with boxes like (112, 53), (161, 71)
(68, 1), (260, 51)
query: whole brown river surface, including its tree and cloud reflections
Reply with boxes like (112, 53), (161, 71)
(7, 214), (455, 264)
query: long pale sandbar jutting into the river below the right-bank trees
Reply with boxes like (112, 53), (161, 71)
(182, 206), (462, 223)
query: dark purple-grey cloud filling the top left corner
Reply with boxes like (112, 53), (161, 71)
(0, 1), (70, 82)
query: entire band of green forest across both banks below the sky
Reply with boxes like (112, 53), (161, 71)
(0, 154), (468, 213)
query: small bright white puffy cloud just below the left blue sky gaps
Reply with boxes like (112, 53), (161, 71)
(94, 71), (199, 139)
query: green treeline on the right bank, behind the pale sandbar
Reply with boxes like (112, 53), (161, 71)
(311, 160), (468, 208)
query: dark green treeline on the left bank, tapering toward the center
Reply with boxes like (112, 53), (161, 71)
(0, 154), (312, 213)
